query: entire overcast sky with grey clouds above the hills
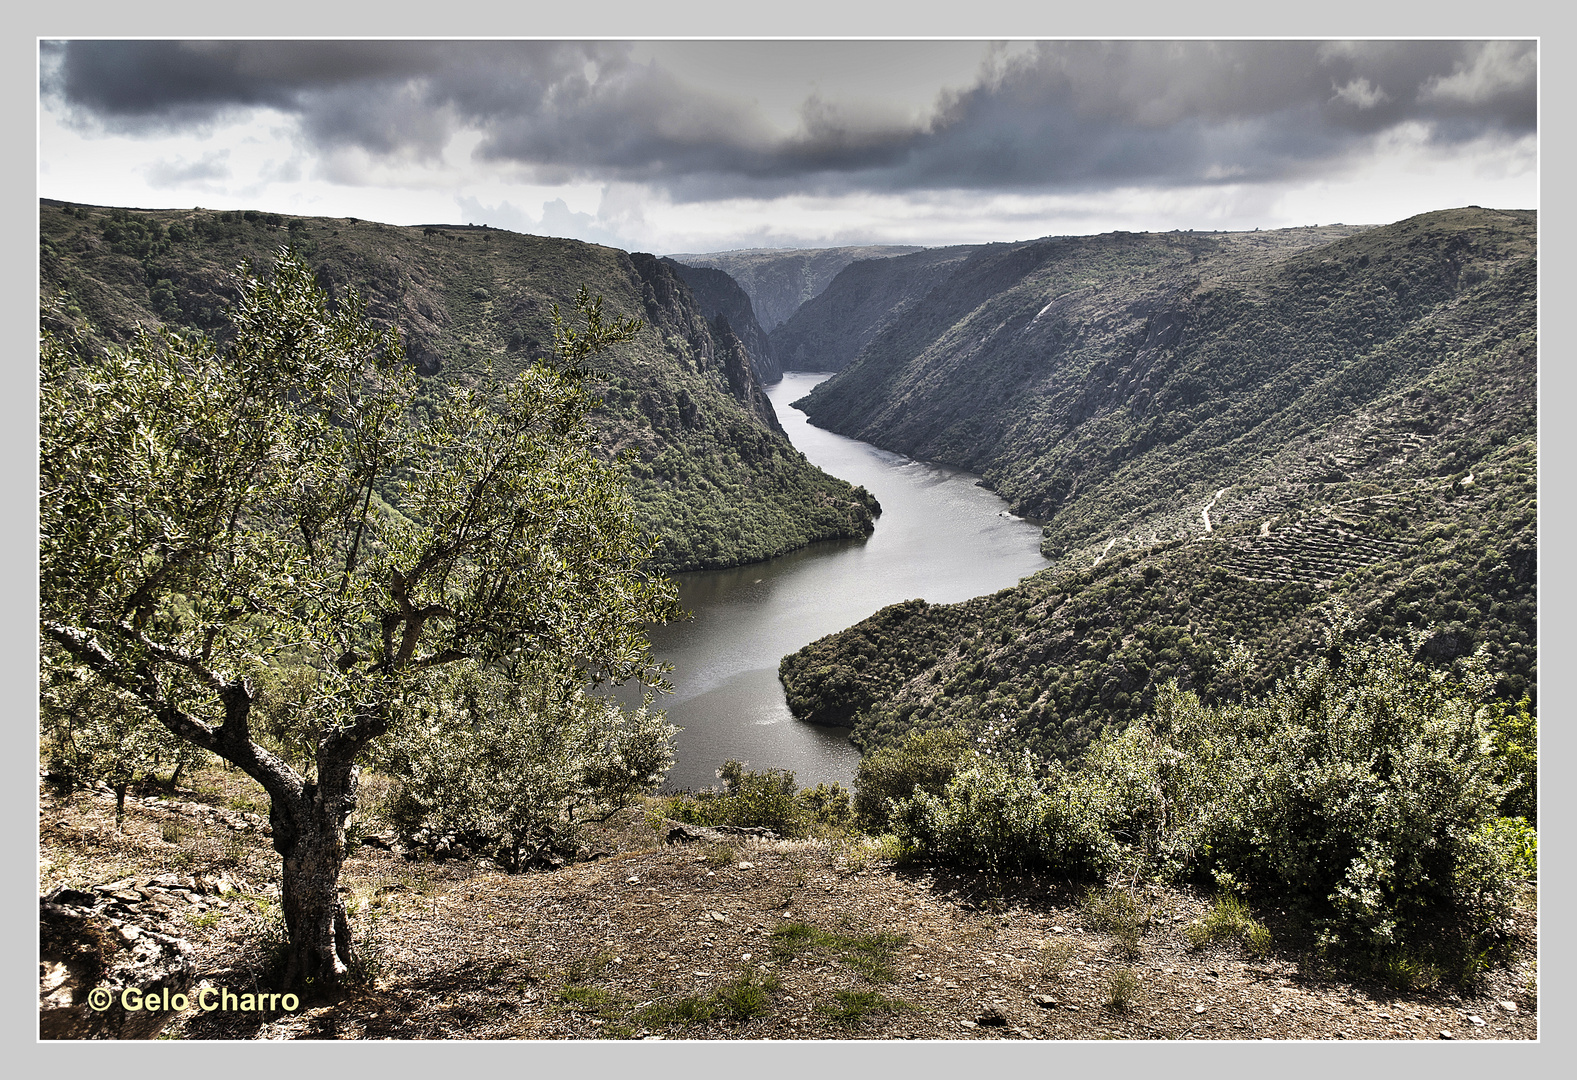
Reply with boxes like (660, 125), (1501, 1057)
(38, 39), (1538, 252)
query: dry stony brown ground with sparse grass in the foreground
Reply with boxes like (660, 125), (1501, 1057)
(39, 769), (1538, 1041)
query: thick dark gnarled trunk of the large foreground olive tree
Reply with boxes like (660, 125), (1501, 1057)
(270, 784), (355, 992)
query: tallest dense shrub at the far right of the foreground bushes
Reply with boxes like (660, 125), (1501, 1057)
(1225, 626), (1514, 952)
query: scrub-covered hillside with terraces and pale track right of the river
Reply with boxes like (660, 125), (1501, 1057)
(781, 208), (1538, 758)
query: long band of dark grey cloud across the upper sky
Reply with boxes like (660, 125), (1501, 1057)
(43, 41), (1538, 199)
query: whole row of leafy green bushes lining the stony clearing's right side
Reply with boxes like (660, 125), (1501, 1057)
(894, 612), (1538, 971)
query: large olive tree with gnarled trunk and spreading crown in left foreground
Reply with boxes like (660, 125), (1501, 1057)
(39, 251), (677, 985)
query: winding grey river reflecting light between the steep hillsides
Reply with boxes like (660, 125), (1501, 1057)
(651, 372), (1047, 790)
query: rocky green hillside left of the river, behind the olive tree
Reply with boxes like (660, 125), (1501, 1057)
(39, 200), (877, 571)
